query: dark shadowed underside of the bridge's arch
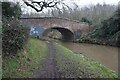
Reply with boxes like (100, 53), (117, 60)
(43, 27), (74, 41)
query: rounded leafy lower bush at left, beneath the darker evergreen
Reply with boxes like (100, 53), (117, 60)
(2, 20), (28, 56)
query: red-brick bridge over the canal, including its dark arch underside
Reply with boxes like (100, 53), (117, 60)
(21, 17), (90, 40)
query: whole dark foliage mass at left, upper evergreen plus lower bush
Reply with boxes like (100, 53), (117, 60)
(2, 2), (29, 57)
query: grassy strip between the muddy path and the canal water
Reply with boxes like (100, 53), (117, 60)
(55, 44), (118, 78)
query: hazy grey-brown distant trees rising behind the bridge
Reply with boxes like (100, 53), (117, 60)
(23, 3), (117, 26)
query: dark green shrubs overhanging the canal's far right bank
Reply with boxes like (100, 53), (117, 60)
(90, 7), (120, 46)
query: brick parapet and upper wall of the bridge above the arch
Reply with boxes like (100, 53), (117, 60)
(20, 17), (90, 40)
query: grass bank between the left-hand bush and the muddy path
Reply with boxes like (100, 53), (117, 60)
(3, 39), (48, 78)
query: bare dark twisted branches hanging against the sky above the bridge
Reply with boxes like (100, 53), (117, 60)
(23, 0), (68, 12)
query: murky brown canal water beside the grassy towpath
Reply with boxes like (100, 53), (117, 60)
(58, 42), (118, 72)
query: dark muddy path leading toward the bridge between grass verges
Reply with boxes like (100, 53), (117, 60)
(33, 42), (60, 78)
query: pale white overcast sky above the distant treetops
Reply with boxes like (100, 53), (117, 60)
(2, 0), (120, 11)
